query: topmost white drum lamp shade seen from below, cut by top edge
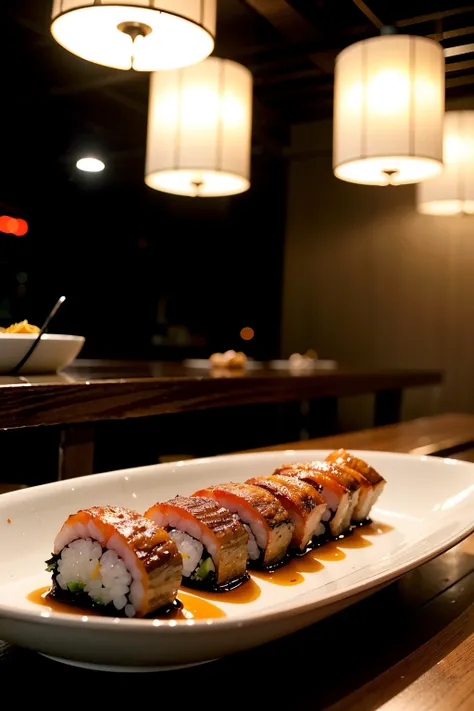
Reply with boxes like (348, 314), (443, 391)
(51, 0), (216, 72)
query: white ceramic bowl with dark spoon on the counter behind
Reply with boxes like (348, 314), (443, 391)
(0, 333), (85, 374)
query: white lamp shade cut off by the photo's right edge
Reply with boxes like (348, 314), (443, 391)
(417, 111), (474, 215)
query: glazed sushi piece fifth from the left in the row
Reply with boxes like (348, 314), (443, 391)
(275, 462), (357, 538)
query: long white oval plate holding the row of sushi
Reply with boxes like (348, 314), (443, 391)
(0, 450), (474, 670)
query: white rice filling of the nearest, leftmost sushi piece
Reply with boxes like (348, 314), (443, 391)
(56, 538), (135, 617)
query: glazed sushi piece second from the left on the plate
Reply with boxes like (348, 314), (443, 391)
(145, 496), (248, 590)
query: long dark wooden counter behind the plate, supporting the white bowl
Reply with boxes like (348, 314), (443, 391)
(0, 360), (442, 429)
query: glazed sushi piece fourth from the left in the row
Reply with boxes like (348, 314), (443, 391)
(246, 474), (327, 551)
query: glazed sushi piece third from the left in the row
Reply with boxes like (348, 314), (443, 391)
(194, 483), (295, 568)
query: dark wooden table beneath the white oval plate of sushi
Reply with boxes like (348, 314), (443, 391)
(0, 415), (474, 711)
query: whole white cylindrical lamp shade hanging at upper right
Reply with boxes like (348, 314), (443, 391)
(333, 35), (445, 185)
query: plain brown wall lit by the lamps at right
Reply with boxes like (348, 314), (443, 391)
(283, 122), (474, 428)
